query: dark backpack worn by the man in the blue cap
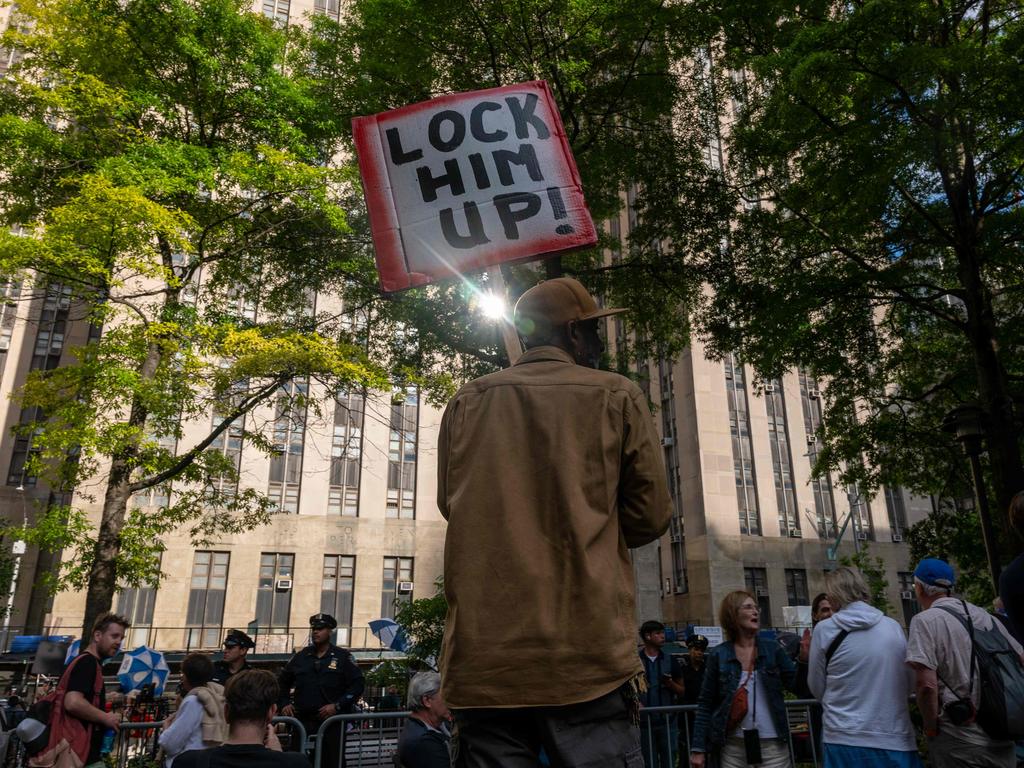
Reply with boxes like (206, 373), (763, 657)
(935, 600), (1024, 741)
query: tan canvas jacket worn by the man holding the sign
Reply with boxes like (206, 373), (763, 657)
(437, 346), (671, 708)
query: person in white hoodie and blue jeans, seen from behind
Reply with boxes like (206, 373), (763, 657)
(807, 567), (921, 768)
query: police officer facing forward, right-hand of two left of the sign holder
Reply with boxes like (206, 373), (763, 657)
(279, 613), (365, 768)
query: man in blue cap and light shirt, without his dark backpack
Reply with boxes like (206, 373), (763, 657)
(906, 557), (1024, 768)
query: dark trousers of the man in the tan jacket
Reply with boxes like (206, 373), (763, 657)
(453, 688), (643, 768)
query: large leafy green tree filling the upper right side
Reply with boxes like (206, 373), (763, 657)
(693, 0), (1024, 554)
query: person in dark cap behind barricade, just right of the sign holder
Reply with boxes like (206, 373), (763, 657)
(640, 622), (683, 768)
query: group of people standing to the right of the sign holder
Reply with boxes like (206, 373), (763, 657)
(640, 558), (1024, 768)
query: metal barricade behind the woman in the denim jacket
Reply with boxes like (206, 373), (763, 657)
(640, 698), (822, 768)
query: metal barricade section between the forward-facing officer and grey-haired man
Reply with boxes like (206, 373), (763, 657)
(313, 712), (410, 768)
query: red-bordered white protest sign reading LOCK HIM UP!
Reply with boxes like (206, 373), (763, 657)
(352, 81), (597, 292)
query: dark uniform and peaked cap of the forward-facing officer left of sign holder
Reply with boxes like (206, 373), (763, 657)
(279, 613), (365, 734)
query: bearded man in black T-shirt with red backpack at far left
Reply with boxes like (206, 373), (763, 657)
(30, 612), (131, 768)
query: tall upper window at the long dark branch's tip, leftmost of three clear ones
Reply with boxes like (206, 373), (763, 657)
(267, 379), (309, 514)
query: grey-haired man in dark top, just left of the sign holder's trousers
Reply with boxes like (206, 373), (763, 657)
(398, 672), (452, 768)
